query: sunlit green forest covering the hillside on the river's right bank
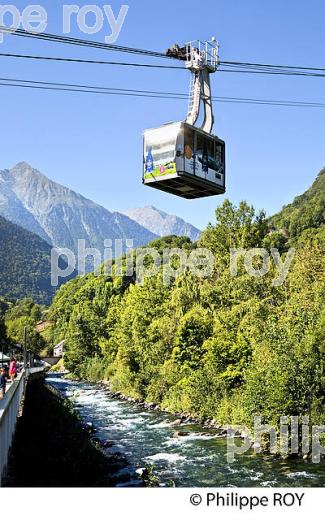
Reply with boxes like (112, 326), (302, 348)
(45, 170), (325, 424)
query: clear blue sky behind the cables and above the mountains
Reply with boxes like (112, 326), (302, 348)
(0, 0), (325, 228)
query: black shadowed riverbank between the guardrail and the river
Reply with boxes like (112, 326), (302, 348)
(4, 380), (141, 487)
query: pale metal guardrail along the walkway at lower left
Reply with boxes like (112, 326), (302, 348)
(0, 367), (44, 486)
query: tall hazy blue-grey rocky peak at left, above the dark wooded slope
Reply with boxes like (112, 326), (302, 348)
(0, 162), (157, 252)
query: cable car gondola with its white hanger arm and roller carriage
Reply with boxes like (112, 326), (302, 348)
(143, 40), (225, 199)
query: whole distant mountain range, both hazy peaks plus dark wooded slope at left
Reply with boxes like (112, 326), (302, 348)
(0, 162), (200, 303)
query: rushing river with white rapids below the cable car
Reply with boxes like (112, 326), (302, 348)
(46, 375), (325, 487)
